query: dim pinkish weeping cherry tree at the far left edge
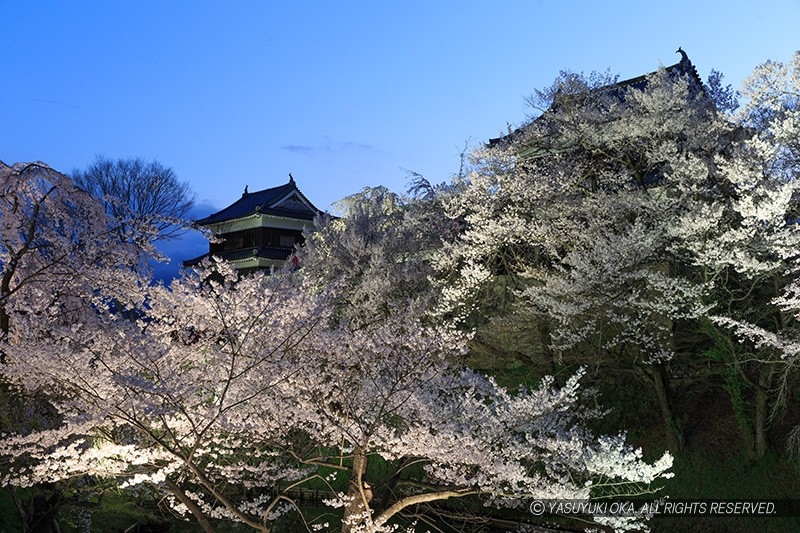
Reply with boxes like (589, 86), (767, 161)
(0, 162), (147, 340)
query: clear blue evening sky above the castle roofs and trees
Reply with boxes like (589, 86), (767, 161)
(0, 0), (800, 278)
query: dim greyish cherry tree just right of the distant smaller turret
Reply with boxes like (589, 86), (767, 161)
(298, 187), (445, 327)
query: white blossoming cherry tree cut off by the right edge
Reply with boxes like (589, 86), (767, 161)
(713, 52), (800, 456)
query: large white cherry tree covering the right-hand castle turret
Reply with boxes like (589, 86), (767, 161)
(438, 65), (726, 449)
